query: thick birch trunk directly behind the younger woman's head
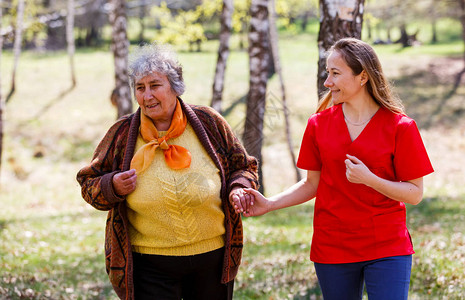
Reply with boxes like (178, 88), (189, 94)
(317, 0), (365, 97)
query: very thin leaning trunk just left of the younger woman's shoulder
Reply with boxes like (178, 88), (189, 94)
(270, 0), (302, 181)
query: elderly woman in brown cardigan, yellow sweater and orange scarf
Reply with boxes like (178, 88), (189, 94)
(77, 44), (257, 300)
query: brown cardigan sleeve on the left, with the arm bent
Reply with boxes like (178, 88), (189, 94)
(76, 117), (130, 210)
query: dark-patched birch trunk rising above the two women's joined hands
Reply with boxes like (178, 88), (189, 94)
(243, 0), (270, 191)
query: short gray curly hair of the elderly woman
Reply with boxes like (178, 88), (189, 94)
(128, 43), (186, 96)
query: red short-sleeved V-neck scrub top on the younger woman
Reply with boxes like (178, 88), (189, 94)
(297, 104), (433, 263)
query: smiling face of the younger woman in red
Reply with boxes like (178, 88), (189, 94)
(324, 51), (363, 104)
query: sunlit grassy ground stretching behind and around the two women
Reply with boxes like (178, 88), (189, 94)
(0, 33), (465, 299)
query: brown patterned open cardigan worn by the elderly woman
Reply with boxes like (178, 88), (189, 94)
(77, 99), (258, 299)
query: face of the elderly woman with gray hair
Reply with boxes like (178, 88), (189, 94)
(134, 72), (177, 130)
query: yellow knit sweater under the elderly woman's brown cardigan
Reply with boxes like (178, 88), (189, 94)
(127, 124), (225, 256)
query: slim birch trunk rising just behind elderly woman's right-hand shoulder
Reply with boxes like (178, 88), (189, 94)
(211, 0), (234, 113)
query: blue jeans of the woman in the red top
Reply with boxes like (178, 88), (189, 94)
(315, 255), (412, 300)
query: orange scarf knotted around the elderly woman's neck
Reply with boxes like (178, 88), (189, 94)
(131, 101), (191, 173)
